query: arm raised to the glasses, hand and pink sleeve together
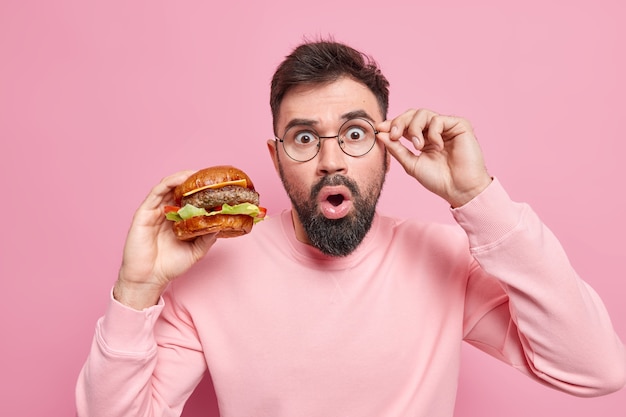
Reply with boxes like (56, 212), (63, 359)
(377, 109), (626, 396)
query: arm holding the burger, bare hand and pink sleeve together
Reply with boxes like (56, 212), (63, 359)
(76, 172), (215, 417)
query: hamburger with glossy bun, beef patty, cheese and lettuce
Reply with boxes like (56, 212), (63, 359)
(164, 165), (266, 240)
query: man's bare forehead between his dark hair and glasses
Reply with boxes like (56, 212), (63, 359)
(277, 78), (382, 130)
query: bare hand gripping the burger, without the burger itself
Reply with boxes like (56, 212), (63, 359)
(113, 171), (216, 310)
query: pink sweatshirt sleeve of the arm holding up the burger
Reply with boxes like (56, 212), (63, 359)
(76, 290), (206, 417)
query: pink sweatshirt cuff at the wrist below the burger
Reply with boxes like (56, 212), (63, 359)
(98, 291), (164, 354)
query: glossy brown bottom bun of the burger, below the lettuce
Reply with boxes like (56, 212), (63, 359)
(173, 214), (254, 240)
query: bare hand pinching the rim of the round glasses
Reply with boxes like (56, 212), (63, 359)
(376, 109), (492, 207)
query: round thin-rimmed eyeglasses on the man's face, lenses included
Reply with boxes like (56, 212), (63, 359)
(275, 118), (379, 162)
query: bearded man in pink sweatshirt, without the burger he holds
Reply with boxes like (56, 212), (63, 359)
(77, 41), (626, 417)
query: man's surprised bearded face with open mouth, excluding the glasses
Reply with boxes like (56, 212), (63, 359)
(268, 78), (388, 256)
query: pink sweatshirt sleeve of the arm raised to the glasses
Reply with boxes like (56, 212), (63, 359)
(452, 179), (626, 396)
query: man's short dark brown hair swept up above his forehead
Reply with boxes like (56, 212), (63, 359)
(270, 40), (389, 130)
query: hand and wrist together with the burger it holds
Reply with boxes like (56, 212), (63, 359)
(113, 165), (266, 310)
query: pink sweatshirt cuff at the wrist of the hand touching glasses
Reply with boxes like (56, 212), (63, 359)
(450, 178), (526, 250)
